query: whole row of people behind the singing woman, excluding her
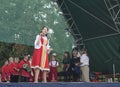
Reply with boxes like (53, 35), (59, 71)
(0, 49), (89, 82)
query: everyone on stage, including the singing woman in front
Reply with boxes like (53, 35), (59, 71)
(0, 26), (89, 83)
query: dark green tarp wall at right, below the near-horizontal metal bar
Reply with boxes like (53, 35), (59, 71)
(85, 35), (120, 73)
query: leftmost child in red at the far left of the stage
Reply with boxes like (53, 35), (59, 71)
(1, 60), (10, 82)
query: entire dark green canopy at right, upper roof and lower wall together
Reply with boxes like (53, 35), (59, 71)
(57, 0), (120, 73)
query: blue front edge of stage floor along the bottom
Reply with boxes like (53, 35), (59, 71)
(0, 82), (120, 87)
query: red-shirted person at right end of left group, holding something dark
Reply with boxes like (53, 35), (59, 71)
(19, 54), (30, 82)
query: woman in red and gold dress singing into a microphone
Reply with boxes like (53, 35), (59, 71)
(32, 27), (52, 83)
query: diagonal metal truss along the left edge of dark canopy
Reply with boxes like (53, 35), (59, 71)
(57, 0), (85, 49)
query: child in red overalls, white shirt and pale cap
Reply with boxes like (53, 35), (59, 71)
(49, 53), (59, 82)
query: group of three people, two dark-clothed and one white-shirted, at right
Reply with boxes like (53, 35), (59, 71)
(58, 48), (90, 82)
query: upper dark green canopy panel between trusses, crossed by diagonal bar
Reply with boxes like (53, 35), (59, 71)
(58, 0), (118, 40)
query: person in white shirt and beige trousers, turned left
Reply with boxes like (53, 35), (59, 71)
(80, 49), (90, 82)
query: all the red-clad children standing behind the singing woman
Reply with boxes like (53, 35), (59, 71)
(0, 53), (59, 82)
